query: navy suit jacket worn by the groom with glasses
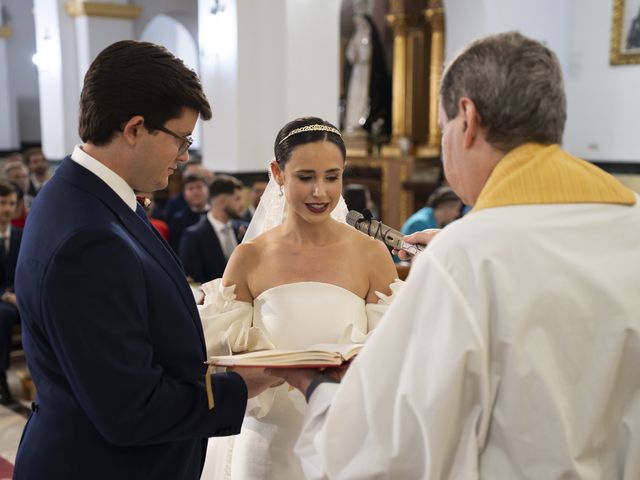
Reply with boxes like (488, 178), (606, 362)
(14, 157), (247, 480)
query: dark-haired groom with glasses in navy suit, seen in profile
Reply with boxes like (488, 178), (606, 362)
(14, 40), (274, 480)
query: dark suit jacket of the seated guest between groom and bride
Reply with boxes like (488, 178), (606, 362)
(180, 215), (247, 283)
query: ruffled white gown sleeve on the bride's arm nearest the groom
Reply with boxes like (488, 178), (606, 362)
(198, 278), (274, 356)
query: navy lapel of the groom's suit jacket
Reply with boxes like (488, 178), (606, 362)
(56, 157), (204, 343)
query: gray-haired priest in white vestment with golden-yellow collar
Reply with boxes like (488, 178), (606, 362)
(272, 33), (640, 480)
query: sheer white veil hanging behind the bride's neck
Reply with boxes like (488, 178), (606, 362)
(242, 163), (349, 242)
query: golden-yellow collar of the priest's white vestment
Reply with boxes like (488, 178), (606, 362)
(473, 143), (636, 212)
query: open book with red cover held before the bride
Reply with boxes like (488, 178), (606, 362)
(207, 343), (364, 368)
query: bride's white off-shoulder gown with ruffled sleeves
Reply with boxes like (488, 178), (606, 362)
(199, 279), (402, 480)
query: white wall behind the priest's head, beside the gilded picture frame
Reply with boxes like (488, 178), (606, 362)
(444, 0), (640, 162)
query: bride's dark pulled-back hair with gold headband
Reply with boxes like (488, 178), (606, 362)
(273, 117), (347, 169)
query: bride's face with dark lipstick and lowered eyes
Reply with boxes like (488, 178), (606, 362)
(280, 141), (344, 222)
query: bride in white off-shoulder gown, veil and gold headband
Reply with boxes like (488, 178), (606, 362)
(200, 117), (400, 480)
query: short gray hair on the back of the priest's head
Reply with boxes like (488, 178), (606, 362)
(440, 32), (567, 152)
